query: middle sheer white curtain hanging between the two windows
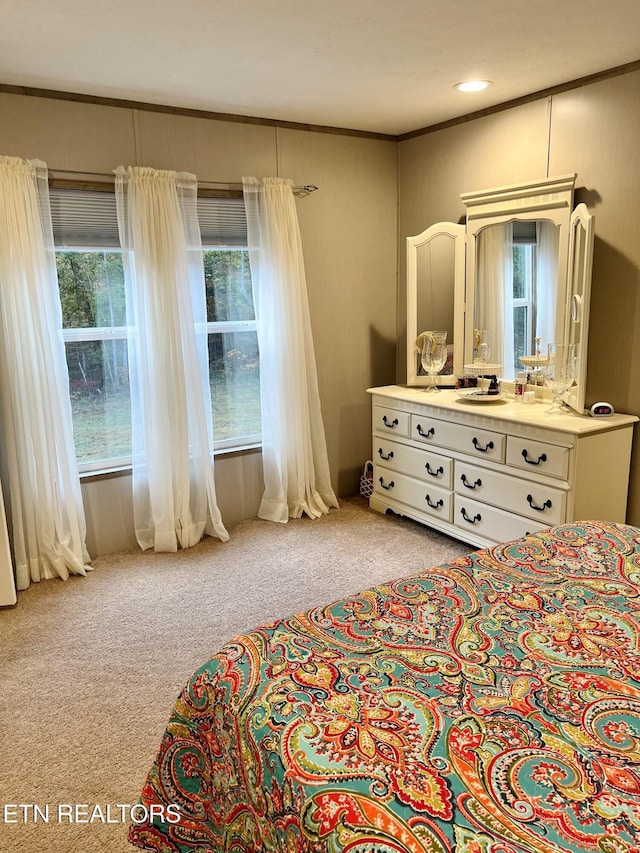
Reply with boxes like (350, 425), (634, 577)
(116, 166), (229, 551)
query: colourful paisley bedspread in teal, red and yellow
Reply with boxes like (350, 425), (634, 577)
(129, 522), (640, 853)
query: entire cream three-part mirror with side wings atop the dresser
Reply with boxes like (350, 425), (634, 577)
(407, 174), (593, 412)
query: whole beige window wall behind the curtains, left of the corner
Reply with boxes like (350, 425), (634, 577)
(0, 94), (397, 556)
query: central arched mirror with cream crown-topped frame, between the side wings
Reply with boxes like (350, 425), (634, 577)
(462, 175), (576, 380)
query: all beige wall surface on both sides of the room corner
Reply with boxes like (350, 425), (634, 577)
(0, 66), (640, 553)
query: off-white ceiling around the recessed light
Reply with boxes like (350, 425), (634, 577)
(0, 0), (640, 135)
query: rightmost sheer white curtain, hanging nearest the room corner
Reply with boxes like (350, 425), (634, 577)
(243, 178), (338, 522)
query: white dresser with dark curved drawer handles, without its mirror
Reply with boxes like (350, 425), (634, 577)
(369, 385), (638, 547)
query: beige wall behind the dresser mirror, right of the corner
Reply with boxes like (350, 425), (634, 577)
(398, 72), (640, 525)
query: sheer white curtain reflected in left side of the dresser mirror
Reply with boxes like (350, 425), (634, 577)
(476, 222), (514, 376)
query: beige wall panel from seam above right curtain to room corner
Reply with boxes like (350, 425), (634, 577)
(278, 130), (398, 495)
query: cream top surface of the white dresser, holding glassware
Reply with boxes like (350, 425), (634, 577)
(367, 385), (638, 434)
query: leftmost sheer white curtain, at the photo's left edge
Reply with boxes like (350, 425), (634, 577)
(0, 157), (90, 589)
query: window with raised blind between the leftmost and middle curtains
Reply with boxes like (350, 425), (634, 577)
(50, 189), (131, 471)
